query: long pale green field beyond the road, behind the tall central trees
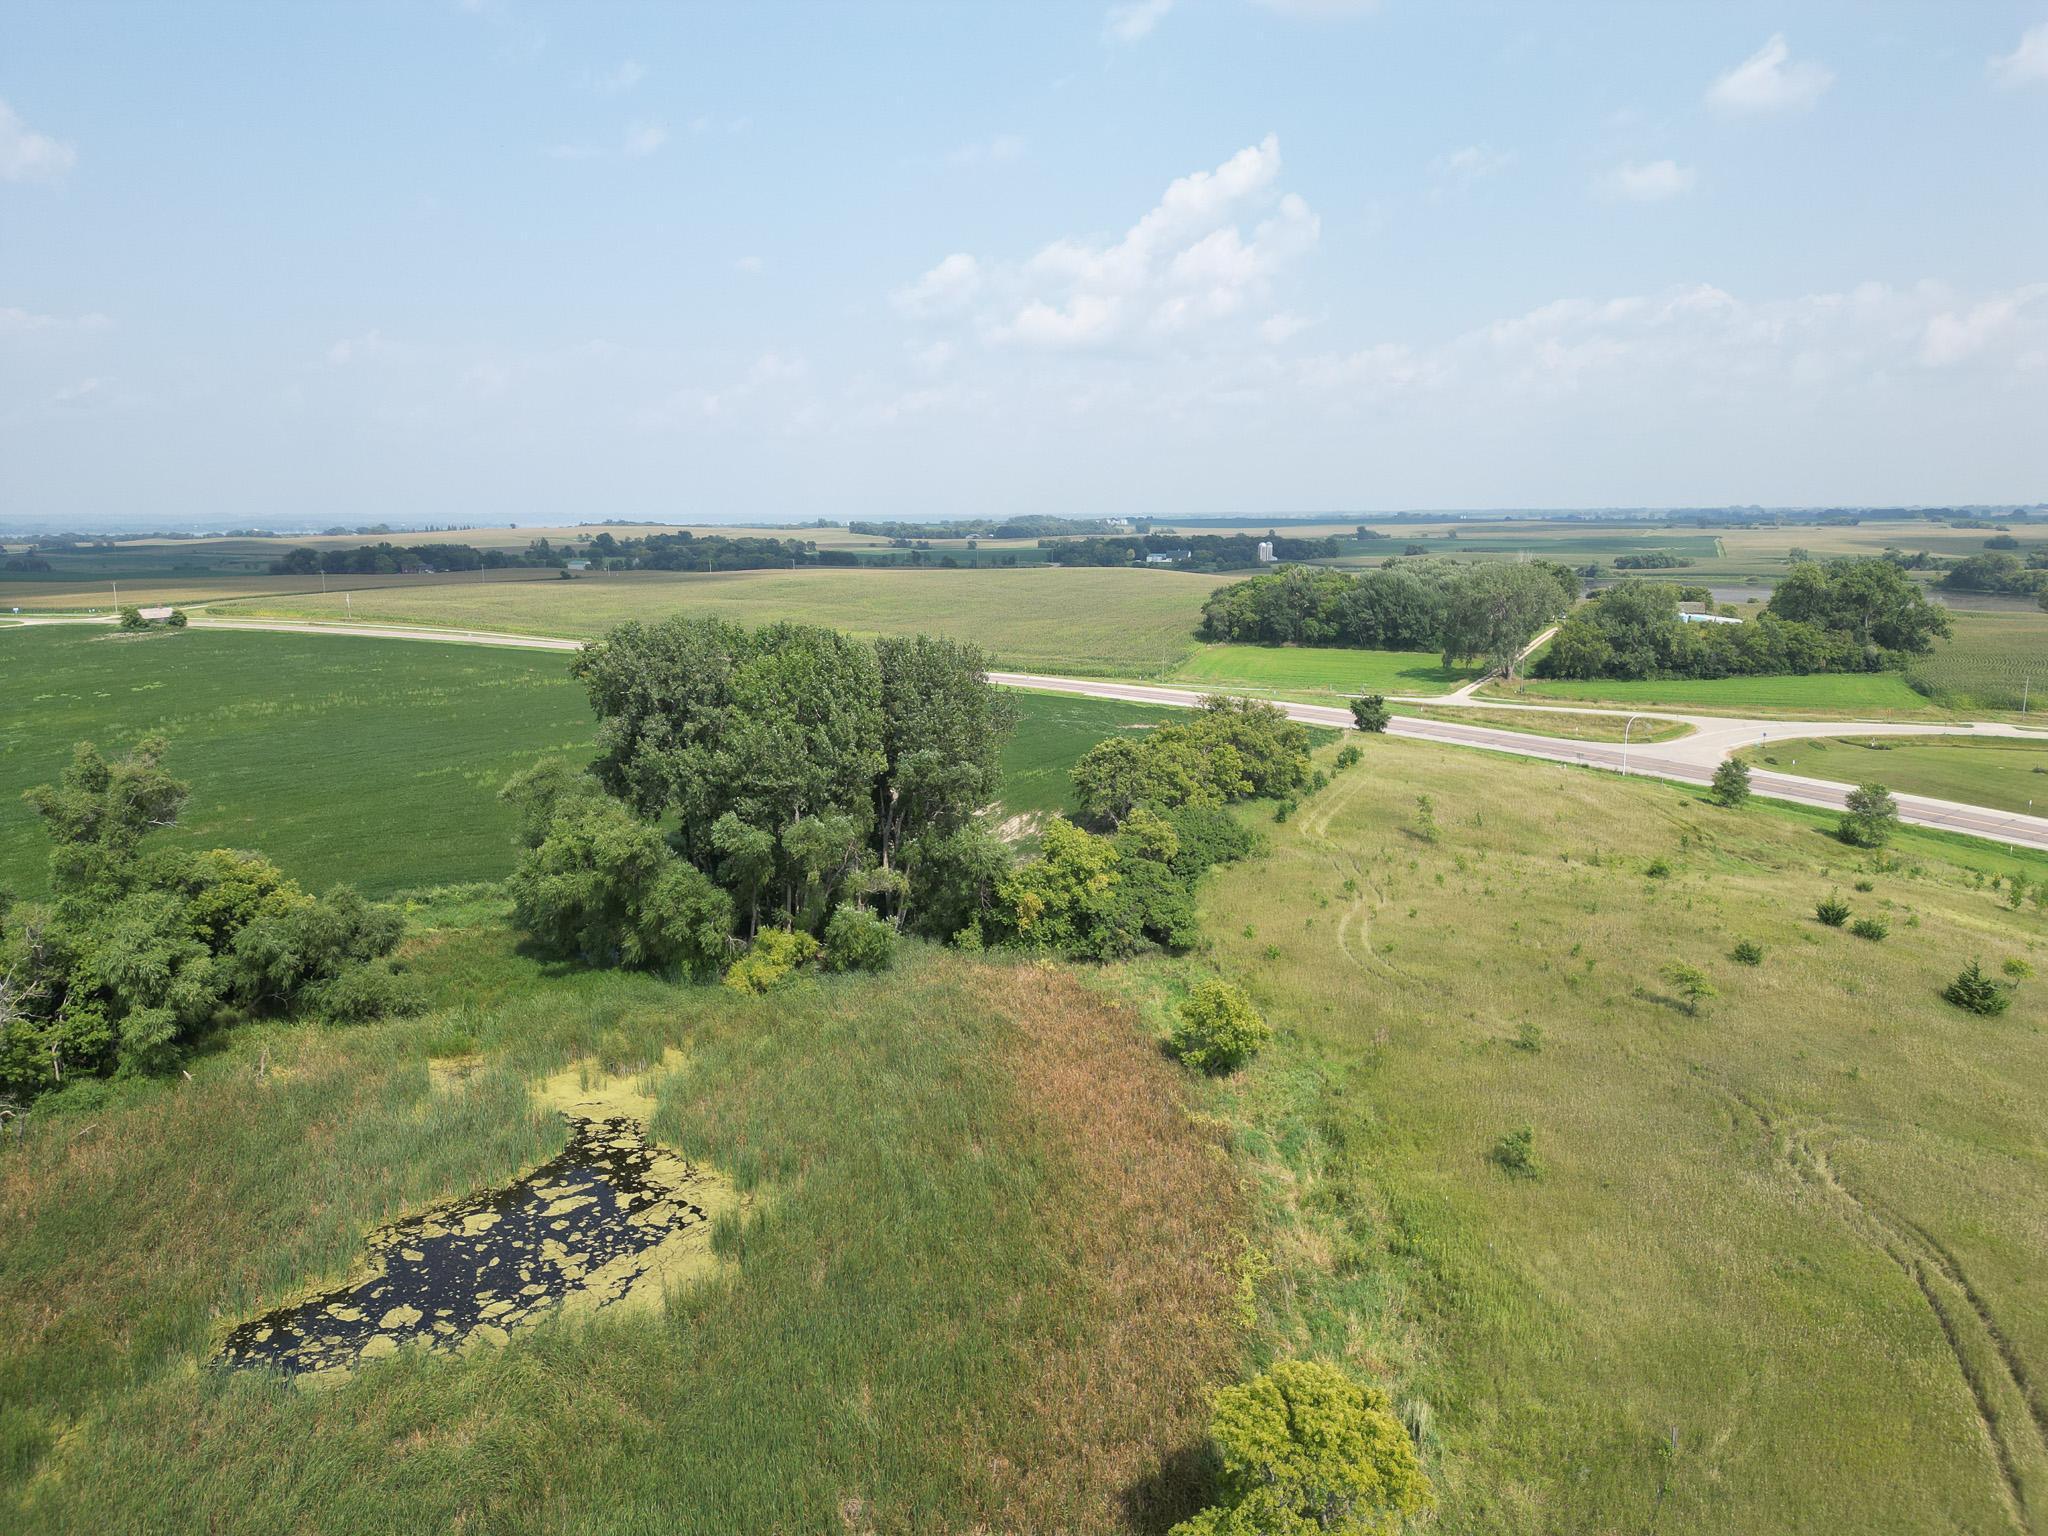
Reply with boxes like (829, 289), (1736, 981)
(219, 567), (1231, 678)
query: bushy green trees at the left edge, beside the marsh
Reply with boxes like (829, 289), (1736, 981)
(0, 737), (412, 1094)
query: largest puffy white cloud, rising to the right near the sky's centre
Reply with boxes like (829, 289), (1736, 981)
(895, 135), (1321, 348)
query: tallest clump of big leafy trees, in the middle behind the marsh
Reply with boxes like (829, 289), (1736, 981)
(504, 618), (1012, 975)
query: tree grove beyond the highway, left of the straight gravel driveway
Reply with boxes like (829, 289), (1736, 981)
(1200, 561), (1579, 672)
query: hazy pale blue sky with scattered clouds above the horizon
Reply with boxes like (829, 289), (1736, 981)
(0, 0), (2048, 526)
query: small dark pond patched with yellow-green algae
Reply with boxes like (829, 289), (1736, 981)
(221, 1053), (743, 1378)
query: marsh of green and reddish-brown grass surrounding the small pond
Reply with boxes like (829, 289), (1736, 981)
(0, 922), (1243, 1536)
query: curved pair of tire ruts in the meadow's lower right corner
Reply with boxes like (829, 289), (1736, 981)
(1708, 1081), (2048, 1536)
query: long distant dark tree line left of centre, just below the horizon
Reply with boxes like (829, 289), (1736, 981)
(270, 528), (860, 575)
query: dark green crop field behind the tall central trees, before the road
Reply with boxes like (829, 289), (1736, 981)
(0, 625), (1174, 897)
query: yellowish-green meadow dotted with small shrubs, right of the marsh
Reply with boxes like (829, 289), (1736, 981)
(1202, 739), (2048, 1536)
